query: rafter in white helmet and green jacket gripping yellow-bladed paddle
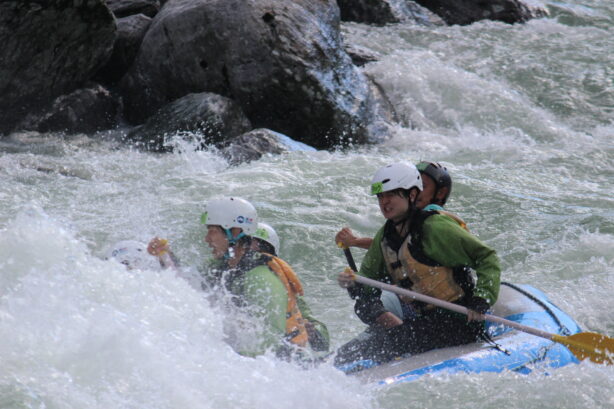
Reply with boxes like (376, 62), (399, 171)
(335, 162), (501, 365)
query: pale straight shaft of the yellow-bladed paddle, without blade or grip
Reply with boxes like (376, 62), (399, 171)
(354, 274), (556, 341)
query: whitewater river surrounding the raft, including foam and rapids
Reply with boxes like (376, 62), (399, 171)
(0, 0), (614, 409)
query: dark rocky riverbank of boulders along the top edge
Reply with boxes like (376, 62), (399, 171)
(0, 0), (547, 162)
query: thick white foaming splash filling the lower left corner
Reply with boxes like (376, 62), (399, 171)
(0, 207), (370, 408)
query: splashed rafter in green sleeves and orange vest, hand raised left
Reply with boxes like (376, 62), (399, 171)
(147, 197), (309, 359)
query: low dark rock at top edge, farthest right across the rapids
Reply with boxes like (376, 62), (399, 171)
(416, 0), (548, 25)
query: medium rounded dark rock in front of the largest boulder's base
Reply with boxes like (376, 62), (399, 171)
(128, 92), (252, 152)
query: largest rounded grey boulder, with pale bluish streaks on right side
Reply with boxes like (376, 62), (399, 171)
(121, 0), (390, 148)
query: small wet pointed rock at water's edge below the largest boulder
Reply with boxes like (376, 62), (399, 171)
(220, 128), (288, 165)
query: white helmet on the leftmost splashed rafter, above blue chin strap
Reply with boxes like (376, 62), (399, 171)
(200, 197), (258, 236)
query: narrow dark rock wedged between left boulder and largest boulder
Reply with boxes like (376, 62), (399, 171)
(96, 14), (151, 84)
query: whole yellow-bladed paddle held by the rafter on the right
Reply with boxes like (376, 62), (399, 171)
(341, 246), (614, 365)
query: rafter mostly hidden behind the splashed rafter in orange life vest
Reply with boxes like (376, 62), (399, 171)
(252, 222), (330, 352)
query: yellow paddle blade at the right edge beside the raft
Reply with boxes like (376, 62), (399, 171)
(552, 332), (614, 365)
